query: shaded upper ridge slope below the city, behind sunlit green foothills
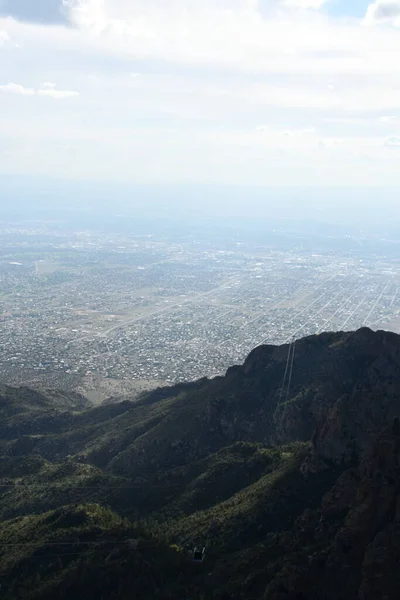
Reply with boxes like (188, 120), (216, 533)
(0, 328), (400, 477)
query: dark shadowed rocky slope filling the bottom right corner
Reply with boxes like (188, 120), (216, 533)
(265, 419), (400, 600)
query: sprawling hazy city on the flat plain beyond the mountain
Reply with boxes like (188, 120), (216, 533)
(0, 221), (400, 401)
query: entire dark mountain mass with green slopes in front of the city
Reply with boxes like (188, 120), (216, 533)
(0, 328), (400, 600)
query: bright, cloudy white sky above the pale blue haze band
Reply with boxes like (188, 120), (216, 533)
(0, 0), (400, 187)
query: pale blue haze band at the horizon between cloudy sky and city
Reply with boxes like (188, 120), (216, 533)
(0, 176), (400, 233)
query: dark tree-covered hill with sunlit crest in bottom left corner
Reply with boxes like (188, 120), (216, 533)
(0, 504), (194, 600)
